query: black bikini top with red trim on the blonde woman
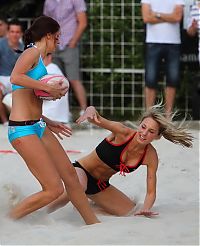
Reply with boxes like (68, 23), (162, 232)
(96, 133), (148, 176)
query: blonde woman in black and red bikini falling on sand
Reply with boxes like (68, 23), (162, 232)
(49, 105), (193, 217)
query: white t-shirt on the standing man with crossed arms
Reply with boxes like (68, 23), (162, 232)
(141, 0), (185, 44)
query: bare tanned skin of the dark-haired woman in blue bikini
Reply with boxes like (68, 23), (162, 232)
(9, 21), (99, 224)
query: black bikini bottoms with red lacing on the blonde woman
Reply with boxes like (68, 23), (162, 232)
(73, 161), (110, 195)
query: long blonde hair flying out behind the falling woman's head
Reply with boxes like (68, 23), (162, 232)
(141, 103), (194, 148)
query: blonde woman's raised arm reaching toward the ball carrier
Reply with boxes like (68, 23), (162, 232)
(76, 106), (133, 134)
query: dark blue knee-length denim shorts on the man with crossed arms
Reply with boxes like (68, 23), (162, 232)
(145, 43), (180, 89)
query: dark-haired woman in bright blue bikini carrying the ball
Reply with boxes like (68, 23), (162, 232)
(8, 16), (98, 224)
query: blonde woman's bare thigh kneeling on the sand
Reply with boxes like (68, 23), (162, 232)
(88, 185), (135, 216)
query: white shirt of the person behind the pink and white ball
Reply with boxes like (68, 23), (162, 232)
(42, 63), (69, 123)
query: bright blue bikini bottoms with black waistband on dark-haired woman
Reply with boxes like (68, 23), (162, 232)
(8, 119), (46, 143)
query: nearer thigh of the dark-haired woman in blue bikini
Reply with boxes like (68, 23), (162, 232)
(12, 135), (62, 190)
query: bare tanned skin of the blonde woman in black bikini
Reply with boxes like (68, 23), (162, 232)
(49, 107), (160, 217)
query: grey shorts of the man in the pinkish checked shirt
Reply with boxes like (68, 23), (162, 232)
(53, 46), (80, 80)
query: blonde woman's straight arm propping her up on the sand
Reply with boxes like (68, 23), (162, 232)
(135, 149), (158, 217)
